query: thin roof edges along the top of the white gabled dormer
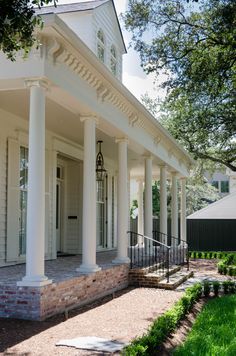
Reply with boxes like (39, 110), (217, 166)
(35, 0), (127, 53)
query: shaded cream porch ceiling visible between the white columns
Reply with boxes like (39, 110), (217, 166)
(0, 88), (161, 177)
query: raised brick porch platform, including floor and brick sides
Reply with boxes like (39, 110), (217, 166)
(0, 251), (129, 320)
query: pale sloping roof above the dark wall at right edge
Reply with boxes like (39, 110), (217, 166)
(187, 192), (236, 220)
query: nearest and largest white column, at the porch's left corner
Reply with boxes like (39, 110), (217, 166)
(17, 80), (52, 287)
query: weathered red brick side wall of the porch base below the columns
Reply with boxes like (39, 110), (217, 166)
(0, 265), (129, 320)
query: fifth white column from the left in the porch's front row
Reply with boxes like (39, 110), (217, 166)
(160, 166), (167, 244)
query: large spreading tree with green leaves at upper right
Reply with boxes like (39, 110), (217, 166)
(124, 0), (236, 171)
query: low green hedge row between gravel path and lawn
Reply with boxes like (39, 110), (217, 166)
(122, 283), (202, 356)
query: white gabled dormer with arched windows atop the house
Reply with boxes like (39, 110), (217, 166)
(37, 0), (126, 80)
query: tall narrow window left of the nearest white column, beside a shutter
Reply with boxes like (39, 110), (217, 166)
(19, 147), (28, 255)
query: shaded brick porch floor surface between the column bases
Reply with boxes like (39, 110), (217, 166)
(0, 250), (117, 285)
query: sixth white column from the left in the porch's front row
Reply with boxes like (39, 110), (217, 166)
(171, 172), (178, 246)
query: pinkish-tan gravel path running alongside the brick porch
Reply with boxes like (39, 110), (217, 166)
(0, 288), (182, 356)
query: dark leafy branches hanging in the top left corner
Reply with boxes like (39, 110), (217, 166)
(0, 0), (57, 60)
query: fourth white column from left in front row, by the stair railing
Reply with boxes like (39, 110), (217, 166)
(144, 157), (152, 252)
